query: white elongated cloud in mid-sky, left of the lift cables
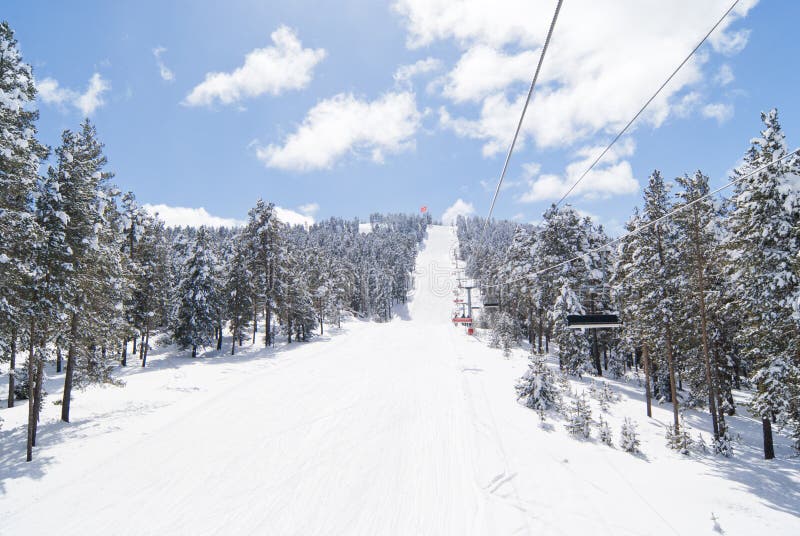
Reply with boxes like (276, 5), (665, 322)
(255, 92), (422, 171)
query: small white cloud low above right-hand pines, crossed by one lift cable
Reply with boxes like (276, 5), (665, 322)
(519, 138), (639, 203)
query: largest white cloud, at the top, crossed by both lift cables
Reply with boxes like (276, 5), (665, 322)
(394, 0), (757, 156)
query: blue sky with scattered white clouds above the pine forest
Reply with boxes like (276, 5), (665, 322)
(2, 0), (800, 232)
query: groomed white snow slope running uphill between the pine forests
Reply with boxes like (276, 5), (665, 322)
(0, 227), (800, 536)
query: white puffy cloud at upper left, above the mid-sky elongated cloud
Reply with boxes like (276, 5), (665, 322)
(183, 26), (326, 106)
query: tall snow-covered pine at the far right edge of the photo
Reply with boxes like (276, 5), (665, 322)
(727, 109), (800, 459)
